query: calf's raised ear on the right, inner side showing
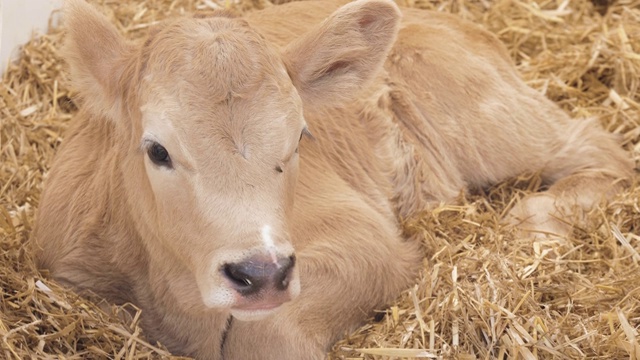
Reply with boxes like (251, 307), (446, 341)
(284, 0), (401, 107)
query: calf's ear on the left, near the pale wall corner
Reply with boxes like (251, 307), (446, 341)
(63, 0), (130, 119)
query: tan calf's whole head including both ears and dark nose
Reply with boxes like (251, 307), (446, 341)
(65, 0), (399, 319)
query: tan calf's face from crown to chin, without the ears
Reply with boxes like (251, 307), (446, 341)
(138, 17), (307, 320)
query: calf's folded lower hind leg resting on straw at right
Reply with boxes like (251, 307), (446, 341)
(507, 116), (633, 238)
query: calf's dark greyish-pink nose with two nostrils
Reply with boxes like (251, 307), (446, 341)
(222, 256), (296, 296)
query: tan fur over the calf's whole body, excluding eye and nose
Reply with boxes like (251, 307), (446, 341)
(34, 0), (632, 359)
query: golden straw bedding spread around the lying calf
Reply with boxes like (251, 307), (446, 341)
(0, 0), (640, 359)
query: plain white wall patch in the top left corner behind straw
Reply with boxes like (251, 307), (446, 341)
(0, 0), (63, 74)
